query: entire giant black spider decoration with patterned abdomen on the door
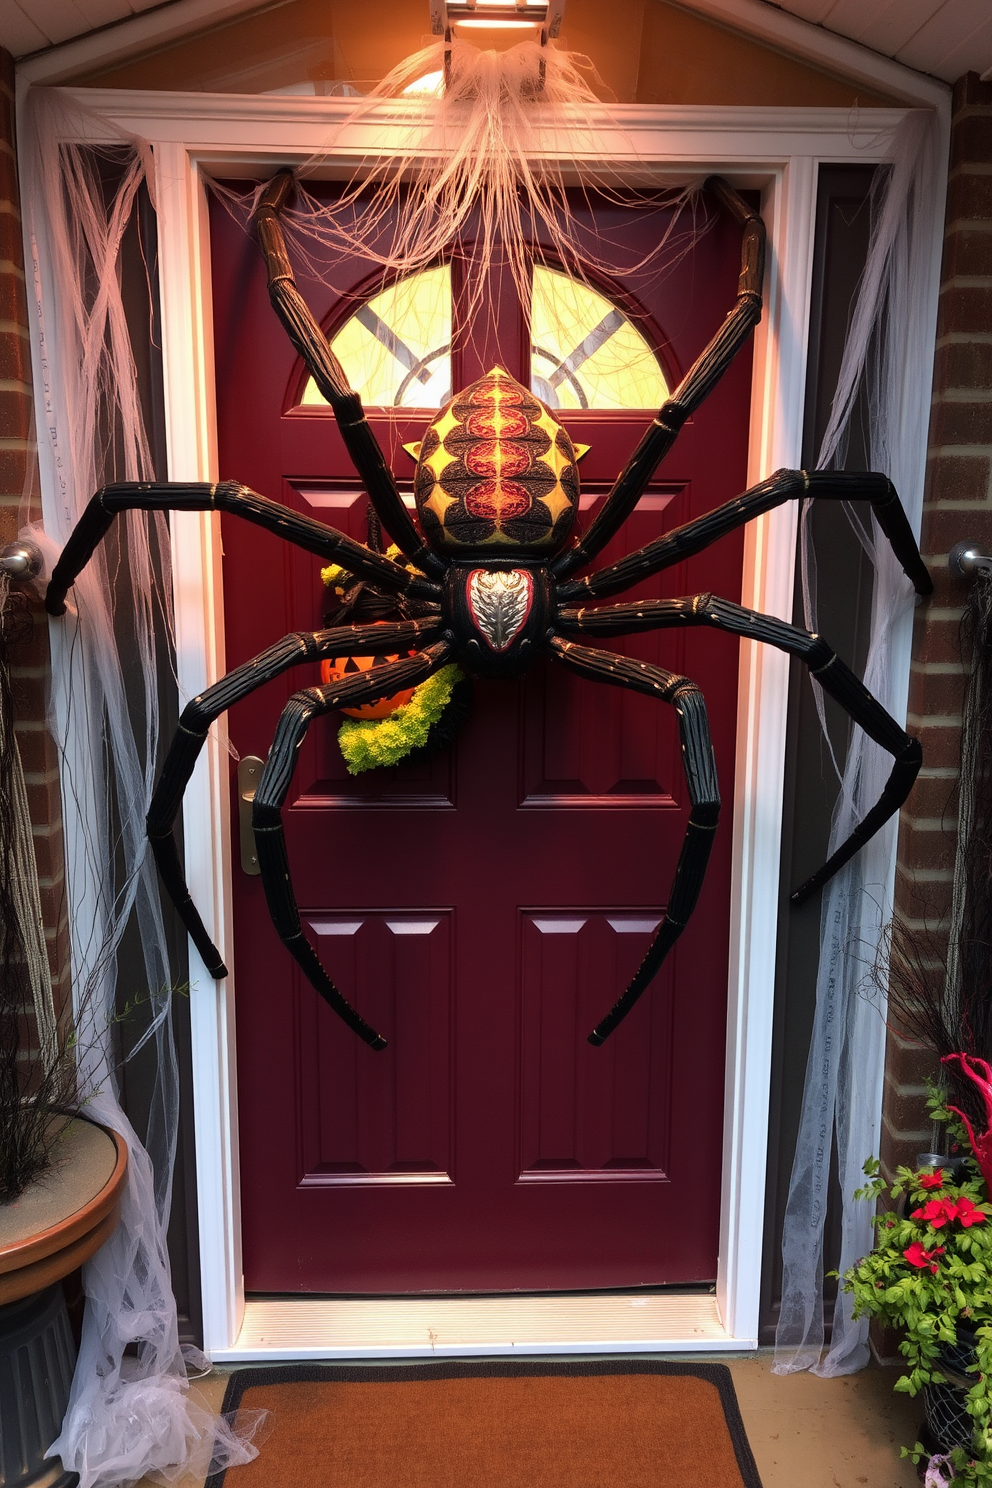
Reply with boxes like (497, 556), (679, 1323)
(46, 171), (931, 1049)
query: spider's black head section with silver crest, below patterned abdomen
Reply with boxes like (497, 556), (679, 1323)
(446, 564), (550, 677)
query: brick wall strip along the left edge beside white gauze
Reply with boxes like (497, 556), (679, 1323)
(0, 48), (68, 1007)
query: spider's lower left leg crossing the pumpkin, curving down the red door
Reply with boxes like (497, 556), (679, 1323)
(251, 638), (452, 1049)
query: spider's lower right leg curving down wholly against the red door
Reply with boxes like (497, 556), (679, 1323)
(549, 637), (720, 1045)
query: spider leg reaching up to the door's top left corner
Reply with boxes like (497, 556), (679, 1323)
(254, 170), (445, 577)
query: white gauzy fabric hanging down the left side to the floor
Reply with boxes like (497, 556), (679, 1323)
(21, 91), (263, 1488)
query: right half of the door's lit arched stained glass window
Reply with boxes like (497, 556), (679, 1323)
(531, 265), (668, 408)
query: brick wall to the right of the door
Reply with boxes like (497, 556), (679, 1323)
(882, 73), (992, 1171)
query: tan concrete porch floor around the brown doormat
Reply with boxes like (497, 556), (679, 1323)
(137, 1350), (921, 1488)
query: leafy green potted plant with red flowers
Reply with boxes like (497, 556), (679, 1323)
(842, 1054), (992, 1488)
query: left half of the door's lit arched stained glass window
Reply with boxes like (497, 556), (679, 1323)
(300, 265), (451, 408)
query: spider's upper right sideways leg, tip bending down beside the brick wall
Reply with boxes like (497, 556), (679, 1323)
(558, 470), (934, 600)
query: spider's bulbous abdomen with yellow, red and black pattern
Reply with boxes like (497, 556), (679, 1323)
(415, 368), (579, 557)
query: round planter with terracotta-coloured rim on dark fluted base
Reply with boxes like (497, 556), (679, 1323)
(0, 1116), (128, 1488)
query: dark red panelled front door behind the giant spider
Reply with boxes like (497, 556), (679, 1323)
(213, 194), (750, 1293)
